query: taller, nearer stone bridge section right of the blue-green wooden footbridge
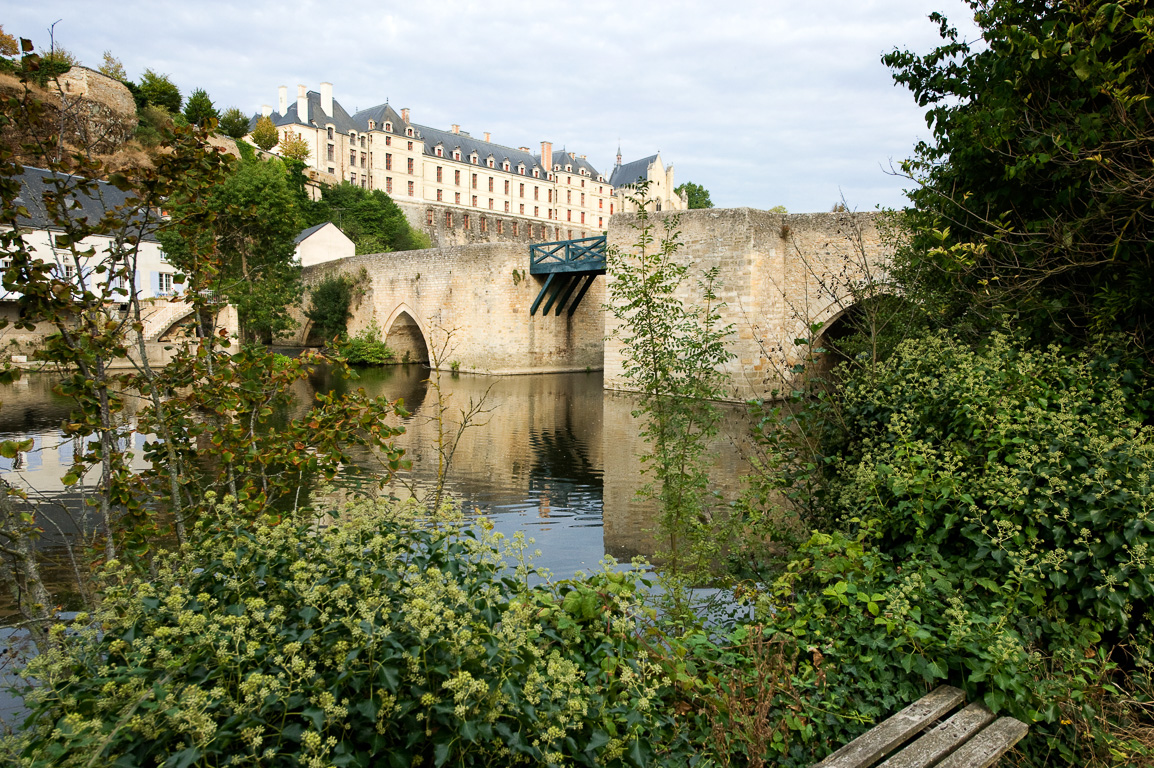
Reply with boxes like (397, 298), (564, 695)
(605, 208), (889, 400)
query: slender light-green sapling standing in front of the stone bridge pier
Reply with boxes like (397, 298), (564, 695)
(607, 190), (732, 611)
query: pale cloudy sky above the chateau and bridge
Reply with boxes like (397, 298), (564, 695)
(0, 0), (977, 212)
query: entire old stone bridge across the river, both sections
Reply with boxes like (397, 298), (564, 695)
(288, 209), (887, 398)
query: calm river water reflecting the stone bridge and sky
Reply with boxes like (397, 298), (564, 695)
(0, 366), (743, 577)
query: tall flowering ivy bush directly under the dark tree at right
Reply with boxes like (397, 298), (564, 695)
(832, 334), (1154, 638)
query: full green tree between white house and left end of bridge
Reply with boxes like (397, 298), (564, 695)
(160, 158), (302, 342)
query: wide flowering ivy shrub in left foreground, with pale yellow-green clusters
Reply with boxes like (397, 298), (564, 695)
(9, 499), (688, 767)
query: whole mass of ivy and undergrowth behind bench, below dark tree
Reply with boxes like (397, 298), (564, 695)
(760, 333), (1154, 765)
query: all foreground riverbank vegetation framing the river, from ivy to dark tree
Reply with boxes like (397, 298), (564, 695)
(0, 0), (1154, 766)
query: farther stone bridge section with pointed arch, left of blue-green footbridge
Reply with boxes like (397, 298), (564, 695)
(294, 242), (605, 375)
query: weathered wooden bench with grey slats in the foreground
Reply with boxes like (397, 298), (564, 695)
(814, 686), (1029, 768)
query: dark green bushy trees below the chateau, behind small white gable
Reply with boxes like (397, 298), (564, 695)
(306, 183), (429, 255)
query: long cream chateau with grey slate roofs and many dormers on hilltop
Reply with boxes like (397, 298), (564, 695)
(252, 83), (623, 246)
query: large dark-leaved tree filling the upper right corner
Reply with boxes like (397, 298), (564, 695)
(884, 0), (1154, 359)
